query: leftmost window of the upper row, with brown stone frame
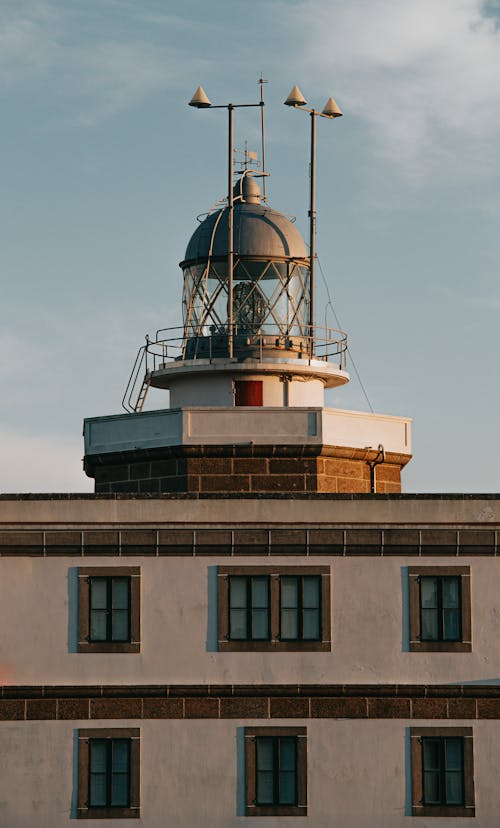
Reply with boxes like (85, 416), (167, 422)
(78, 566), (141, 653)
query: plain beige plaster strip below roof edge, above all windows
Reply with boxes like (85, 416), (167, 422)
(0, 495), (500, 528)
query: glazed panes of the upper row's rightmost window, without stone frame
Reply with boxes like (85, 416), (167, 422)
(420, 575), (462, 641)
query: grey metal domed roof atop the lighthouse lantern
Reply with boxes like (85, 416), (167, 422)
(181, 192), (308, 266)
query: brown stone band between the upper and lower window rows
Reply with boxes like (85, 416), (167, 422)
(0, 685), (500, 721)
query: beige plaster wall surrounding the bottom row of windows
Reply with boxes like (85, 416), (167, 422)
(0, 719), (500, 828)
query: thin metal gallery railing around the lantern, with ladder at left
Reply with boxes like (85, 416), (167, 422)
(122, 325), (347, 413)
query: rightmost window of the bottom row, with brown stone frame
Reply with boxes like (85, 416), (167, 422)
(410, 727), (475, 817)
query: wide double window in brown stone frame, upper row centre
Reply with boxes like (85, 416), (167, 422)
(218, 566), (331, 651)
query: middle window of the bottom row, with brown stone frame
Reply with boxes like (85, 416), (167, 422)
(245, 727), (307, 816)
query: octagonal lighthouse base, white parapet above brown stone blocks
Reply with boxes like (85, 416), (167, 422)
(84, 408), (411, 494)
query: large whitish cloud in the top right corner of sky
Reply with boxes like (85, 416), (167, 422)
(291, 0), (500, 183)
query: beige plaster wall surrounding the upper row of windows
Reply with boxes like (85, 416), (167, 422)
(0, 557), (500, 685)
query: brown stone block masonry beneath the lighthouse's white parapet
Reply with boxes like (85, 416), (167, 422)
(85, 444), (410, 494)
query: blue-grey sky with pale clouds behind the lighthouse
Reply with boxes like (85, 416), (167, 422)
(0, 0), (500, 492)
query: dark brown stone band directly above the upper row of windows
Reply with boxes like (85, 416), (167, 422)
(0, 526), (500, 557)
